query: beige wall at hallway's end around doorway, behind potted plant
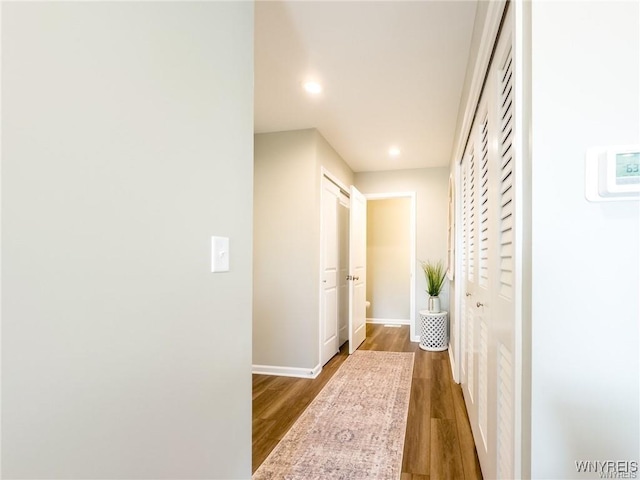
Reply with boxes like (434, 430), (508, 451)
(355, 167), (449, 335)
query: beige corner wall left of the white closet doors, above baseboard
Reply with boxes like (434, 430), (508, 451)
(253, 129), (353, 371)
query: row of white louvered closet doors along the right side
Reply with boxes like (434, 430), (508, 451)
(459, 4), (516, 479)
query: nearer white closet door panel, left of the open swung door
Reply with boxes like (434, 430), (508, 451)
(320, 177), (340, 365)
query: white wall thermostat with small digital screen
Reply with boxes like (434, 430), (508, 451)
(585, 145), (640, 202)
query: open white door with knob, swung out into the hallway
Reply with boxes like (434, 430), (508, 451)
(348, 185), (367, 354)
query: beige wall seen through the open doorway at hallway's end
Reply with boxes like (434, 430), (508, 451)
(367, 198), (411, 321)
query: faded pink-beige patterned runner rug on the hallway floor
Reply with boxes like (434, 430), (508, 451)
(252, 350), (413, 480)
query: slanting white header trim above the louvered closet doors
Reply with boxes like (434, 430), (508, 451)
(453, 0), (507, 169)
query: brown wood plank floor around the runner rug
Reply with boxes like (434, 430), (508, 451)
(253, 324), (482, 480)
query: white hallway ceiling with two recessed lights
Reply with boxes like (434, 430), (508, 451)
(255, 0), (476, 172)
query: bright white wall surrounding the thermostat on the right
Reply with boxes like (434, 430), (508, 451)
(531, 2), (640, 479)
